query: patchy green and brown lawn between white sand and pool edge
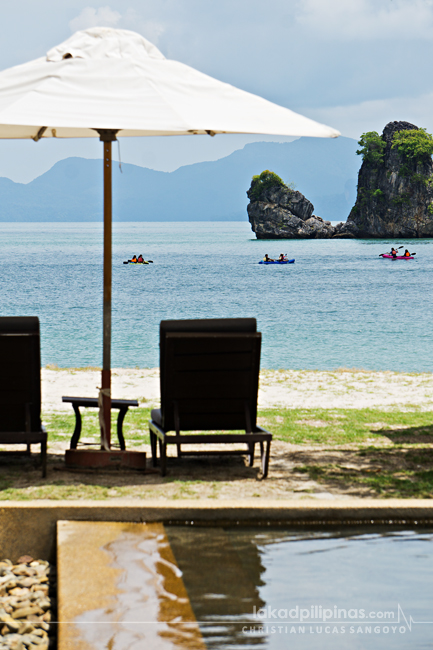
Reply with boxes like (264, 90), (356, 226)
(0, 407), (433, 500)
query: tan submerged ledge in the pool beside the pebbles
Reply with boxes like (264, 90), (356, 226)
(57, 521), (205, 650)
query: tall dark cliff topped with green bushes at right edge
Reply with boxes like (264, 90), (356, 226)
(346, 122), (433, 239)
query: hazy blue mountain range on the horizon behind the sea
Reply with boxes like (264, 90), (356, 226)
(0, 136), (361, 222)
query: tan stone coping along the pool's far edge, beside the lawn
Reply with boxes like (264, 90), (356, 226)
(0, 498), (433, 562)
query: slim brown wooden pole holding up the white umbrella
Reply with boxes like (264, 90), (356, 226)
(98, 129), (117, 450)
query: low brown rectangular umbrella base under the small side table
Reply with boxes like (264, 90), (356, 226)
(65, 449), (146, 470)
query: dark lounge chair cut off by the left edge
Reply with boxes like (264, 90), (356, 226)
(0, 316), (47, 476)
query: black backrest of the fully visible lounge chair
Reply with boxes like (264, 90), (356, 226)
(160, 318), (261, 431)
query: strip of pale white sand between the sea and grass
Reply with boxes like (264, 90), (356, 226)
(42, 368), (433, 411)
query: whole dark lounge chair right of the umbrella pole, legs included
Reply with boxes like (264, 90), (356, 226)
(149, 318), (272, 478)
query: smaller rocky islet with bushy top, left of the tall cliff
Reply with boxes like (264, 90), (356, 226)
(247, 170), (353, 239)
